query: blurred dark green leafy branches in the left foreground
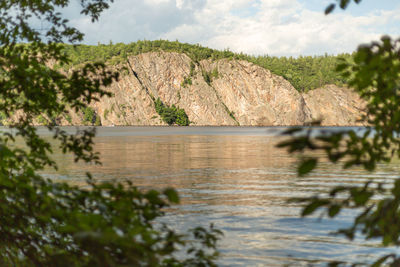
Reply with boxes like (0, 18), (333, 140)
(0, 0), (221, 267)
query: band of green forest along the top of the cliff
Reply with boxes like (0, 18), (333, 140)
(64, 40), (351, 91)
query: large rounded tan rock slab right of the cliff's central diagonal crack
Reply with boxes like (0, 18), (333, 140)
(203, 59), (311, 126)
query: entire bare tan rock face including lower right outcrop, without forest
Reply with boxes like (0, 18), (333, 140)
(7, 52), (365, 126)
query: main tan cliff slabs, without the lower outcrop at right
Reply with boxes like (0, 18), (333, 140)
(95, 52), (311, 126)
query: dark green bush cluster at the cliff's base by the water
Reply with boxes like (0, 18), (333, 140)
(154, 98), (190, 126)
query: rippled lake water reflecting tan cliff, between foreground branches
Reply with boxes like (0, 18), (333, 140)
(36, 127), (399, 266)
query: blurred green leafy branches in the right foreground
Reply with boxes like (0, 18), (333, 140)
(279, 5), (400, 267)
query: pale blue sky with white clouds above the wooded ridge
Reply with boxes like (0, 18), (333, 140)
(63, 0), (400, 56)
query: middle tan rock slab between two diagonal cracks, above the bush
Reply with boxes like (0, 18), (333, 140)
(129, 52), (236, 125)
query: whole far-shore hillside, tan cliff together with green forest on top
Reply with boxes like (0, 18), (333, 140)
(0, 40), (365, 126)
